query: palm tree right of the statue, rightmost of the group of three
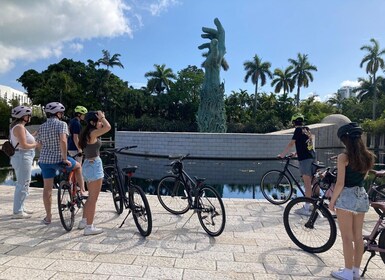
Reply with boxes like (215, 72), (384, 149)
(289, 53), (317, 107)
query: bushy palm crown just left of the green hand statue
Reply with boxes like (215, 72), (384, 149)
(144, 64), (177, 94)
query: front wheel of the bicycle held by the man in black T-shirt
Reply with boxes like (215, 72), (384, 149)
(260, 170), (293, 205)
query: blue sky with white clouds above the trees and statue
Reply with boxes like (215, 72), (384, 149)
(0, 0), (385, 101)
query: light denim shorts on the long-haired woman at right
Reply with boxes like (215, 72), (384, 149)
(335, 186), (369, 213)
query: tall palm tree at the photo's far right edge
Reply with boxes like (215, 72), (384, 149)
(360, 38), (385, 120)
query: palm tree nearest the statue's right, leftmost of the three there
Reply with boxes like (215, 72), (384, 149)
(243, 55), (273, 117)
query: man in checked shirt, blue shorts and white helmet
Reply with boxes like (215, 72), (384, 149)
(36, 102), (84, 225)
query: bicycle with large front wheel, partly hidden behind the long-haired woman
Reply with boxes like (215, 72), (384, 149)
(283, 170), (385, 253)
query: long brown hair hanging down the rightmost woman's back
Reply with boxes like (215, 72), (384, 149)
(341, 135), (374, 173)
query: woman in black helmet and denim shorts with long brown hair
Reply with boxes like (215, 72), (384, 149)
(329, 123), (374, 280)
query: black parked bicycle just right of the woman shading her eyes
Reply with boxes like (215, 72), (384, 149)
(103, 146), (152, 237)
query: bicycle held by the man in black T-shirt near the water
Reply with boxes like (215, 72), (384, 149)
(260, 154), (325, 205)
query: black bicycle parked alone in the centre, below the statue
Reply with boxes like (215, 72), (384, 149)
(157, 154), (226, 236)
